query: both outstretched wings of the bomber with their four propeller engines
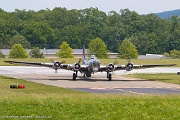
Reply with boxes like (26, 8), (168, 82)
(4, 61), (176, 72)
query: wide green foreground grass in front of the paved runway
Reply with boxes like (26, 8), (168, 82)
(0, 76), (180, 120)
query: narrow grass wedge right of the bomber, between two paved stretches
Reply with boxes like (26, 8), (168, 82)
(126, 73), (180, 84)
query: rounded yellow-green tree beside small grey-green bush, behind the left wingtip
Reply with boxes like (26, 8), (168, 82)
(9, 44), (28, 58)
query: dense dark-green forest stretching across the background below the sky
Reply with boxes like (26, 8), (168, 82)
(0, 8), (180, 54)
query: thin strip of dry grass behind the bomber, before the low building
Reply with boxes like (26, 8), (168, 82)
(0, 58), (180, 67)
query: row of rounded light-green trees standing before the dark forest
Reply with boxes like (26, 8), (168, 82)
(0, 38), (138, 59)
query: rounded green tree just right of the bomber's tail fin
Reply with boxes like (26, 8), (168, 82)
(88, 38), (109, 58)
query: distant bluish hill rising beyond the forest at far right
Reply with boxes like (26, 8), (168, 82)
(156, 9), (180, 19)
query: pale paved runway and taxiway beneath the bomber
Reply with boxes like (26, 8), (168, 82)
(0, 66), (180, 95)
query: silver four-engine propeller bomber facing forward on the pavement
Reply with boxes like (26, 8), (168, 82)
(4, 47), (176, 81)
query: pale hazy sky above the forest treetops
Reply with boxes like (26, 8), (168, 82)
(0, 0), (180, 14)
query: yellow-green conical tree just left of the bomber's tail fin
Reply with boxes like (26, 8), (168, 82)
(56, 42), (74, 58)
